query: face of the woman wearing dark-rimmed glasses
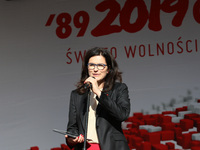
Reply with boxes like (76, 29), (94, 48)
(88, 55), (108, 81)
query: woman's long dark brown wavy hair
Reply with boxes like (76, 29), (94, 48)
(77, 47), (122, 94)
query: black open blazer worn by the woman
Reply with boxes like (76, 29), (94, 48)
(67, 83), (130, 150)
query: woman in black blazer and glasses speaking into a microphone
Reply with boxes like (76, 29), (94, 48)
(65, 47), (130, 150)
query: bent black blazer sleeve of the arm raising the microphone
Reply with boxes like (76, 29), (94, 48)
(97, 83), (130, 121)
